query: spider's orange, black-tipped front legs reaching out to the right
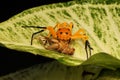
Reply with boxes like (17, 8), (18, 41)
(71, 29), (93, 59)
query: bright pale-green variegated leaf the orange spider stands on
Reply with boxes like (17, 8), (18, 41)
(0, 1), (120, 67)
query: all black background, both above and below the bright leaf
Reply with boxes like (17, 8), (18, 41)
(0, 0), (70, 76)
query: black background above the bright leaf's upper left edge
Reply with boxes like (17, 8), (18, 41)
(0, 0), (70, 22)
